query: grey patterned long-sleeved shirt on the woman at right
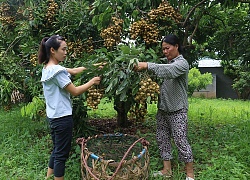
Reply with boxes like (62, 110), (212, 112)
(148, 55), (189, 112)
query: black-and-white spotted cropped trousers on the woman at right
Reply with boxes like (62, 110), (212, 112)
(156, 109), (193, 163)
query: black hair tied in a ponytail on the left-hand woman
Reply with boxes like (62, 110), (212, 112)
(38, 35), (65, 64)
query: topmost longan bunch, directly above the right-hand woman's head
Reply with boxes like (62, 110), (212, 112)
(148, 1), (182, 23)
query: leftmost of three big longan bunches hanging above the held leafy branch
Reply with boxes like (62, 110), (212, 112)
(100, 17), (123, 48)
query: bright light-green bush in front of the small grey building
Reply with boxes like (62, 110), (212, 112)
(188, 67), (213, 96)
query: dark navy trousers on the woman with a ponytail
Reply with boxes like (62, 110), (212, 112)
(49, 116), (73, 177)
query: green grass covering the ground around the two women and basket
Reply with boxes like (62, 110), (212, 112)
(0, 98), (250, 180)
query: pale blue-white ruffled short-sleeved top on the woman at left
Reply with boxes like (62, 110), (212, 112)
(41, 65), (72, 119)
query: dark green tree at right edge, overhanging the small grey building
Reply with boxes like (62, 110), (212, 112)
(205, 4), (250, 99)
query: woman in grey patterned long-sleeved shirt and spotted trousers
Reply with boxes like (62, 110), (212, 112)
(135, 35), (194, 180)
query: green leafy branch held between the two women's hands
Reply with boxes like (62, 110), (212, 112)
(81, 45), (159, 101)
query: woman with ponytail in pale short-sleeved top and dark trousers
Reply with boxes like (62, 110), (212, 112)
(38, 35), (101, 180)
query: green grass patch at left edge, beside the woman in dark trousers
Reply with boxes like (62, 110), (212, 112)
(0, 108), (52, 180)
